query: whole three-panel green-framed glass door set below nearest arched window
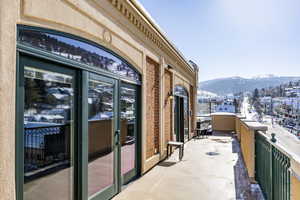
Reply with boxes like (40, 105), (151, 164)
(16, 55), (140, 200)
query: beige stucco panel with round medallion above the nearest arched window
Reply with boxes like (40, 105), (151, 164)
(19, 0), (143, 72)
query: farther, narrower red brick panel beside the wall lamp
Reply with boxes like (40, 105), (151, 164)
(164, 70), (173, 143)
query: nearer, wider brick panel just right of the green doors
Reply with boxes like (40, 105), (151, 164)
(146, 58), (160, 159)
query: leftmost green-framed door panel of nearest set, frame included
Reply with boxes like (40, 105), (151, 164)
(16, 56), (79, 200)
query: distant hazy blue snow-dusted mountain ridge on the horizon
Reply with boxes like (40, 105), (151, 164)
(199, 75), (300, 95)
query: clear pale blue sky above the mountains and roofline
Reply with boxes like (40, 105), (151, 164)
(139, 0), (300, 81)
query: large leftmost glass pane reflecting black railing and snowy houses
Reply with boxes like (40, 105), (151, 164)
(23, 66), (75, 200)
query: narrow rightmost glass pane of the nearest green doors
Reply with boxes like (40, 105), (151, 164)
(120, 85), (137, 182)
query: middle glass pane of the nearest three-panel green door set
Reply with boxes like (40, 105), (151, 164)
(88, 75), (115, 197)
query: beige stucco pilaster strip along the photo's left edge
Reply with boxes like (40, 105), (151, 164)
(0, 0), (18, 200)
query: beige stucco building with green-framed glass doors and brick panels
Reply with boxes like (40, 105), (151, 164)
(0, 0), (198, 200)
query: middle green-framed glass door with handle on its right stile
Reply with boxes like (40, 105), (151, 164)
(86, 73), (120, 200)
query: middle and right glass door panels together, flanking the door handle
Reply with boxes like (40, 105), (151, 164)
(87, 77), (138, 199)
